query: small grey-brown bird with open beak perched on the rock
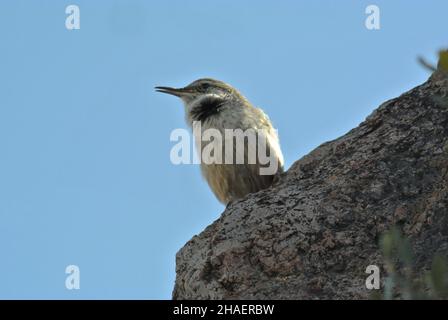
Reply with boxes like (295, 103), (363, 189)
(155, 78), (284, 206)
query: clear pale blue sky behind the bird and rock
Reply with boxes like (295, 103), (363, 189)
(0, 0), (448, 299)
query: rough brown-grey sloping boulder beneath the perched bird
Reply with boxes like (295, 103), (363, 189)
(173, 68), (448, 299)
